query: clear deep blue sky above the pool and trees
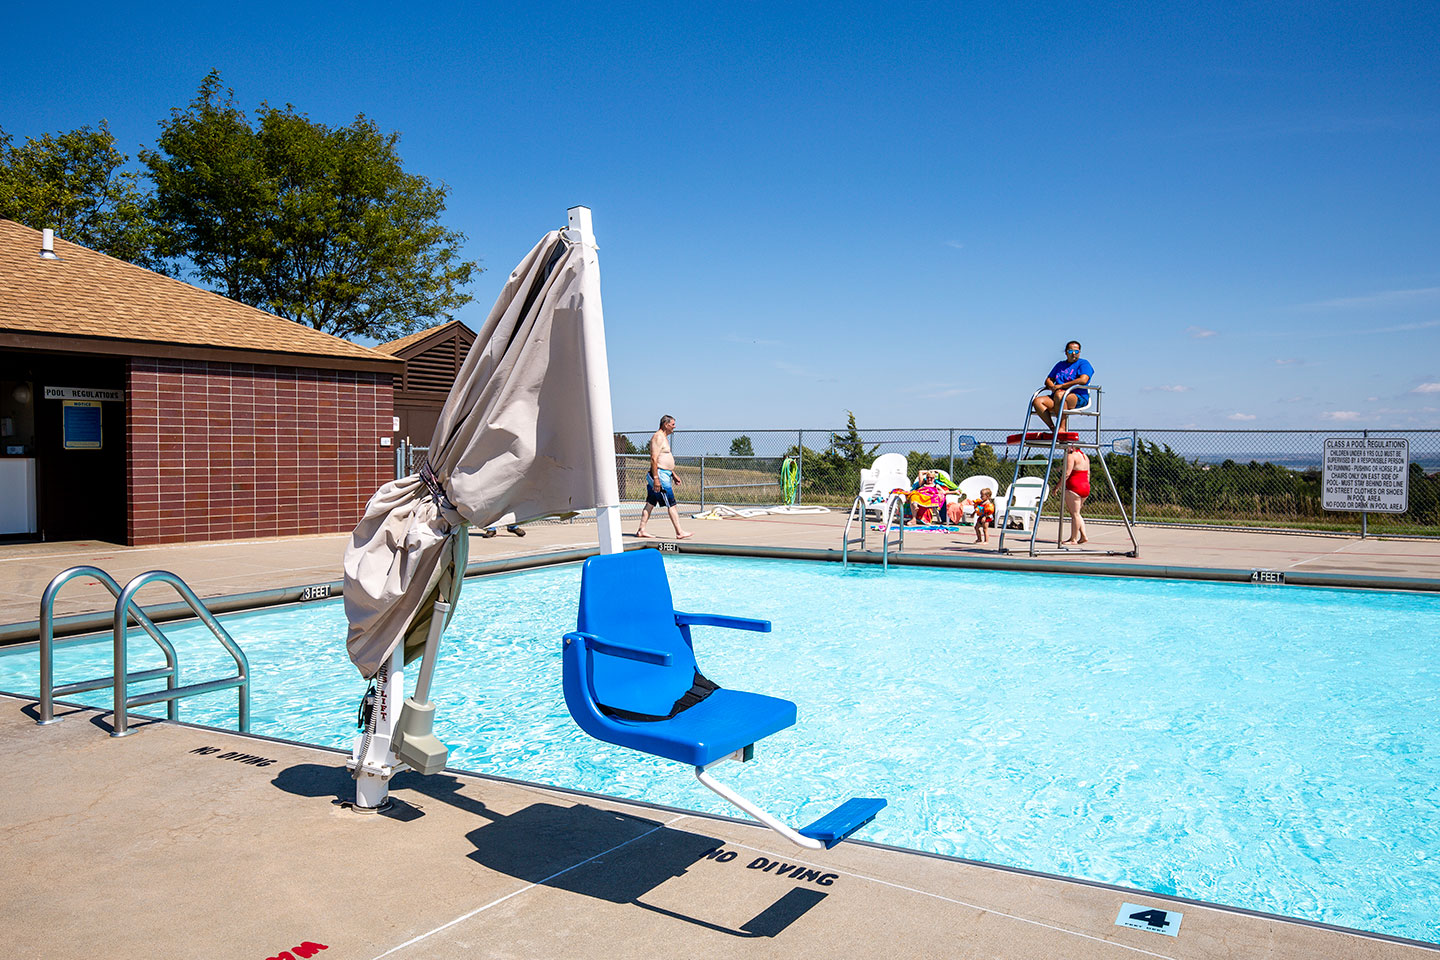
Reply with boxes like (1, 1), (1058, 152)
(0, 3), (1440, 429)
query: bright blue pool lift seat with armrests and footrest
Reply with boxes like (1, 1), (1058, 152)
(563, 550), (886, 849)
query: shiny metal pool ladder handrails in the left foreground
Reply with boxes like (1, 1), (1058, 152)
(37, 566), (251, 737)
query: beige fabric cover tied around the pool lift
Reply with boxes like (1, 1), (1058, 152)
(344, 230), (596, 678)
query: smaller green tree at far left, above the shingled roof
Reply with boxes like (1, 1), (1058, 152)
(0, 119), (164, 272)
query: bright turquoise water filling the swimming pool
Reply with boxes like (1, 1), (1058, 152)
(0, 557), (1440, 941)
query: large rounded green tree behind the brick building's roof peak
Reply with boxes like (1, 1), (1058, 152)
(143, 72), (480, 340)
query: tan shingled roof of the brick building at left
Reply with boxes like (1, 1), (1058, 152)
(0, 220), (397, 370)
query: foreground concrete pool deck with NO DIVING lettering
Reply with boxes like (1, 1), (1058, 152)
(0, 697), (1436, 960)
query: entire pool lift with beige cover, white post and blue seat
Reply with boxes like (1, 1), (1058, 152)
(346, 207), (886, 849)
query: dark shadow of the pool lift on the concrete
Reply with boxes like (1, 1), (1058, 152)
(274, 763), (827, 937)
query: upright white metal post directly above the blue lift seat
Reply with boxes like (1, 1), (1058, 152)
(566, 207), (625, 553)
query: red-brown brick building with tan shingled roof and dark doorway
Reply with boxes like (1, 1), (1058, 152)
(0, 220), (402, 544)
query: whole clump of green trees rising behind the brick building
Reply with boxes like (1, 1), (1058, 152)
(0, 72), (481, 340)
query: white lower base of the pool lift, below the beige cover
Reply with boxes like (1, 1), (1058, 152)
(346, 602), (451, 813)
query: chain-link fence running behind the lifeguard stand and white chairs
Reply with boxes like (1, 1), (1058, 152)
(397, 425), (1440, 537)
